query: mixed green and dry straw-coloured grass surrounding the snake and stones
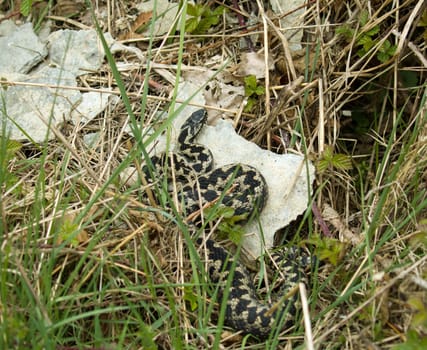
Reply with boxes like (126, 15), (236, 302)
(0, 0), (427, 350)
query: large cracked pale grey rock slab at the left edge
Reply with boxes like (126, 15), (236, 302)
(0, 21), (123, 143)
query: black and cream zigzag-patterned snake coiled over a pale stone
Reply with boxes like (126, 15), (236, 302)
(143, 109), (310, 338)
